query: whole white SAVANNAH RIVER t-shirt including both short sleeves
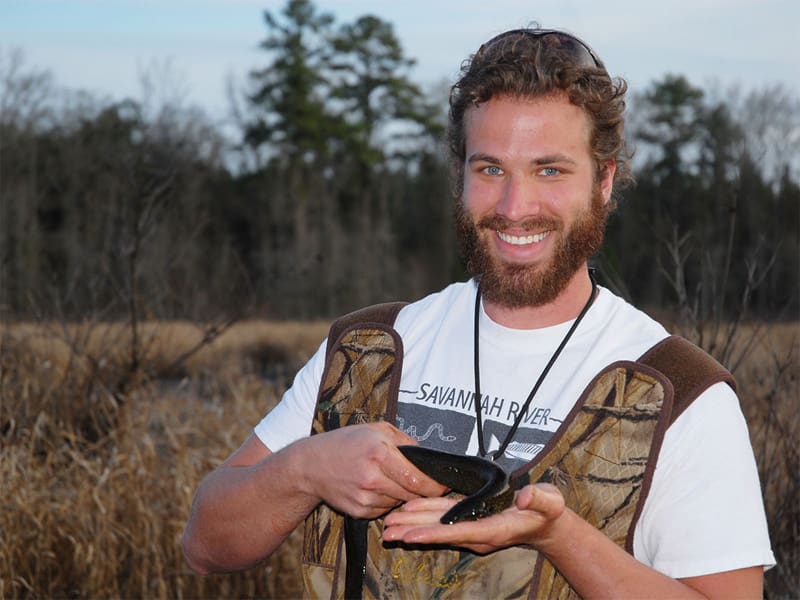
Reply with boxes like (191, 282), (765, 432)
(255, 281), (774, 577)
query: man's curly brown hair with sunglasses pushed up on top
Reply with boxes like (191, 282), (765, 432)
(448, 28), (633, 202)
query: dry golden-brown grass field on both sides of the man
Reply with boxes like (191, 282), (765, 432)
(0, 322), (800, 599)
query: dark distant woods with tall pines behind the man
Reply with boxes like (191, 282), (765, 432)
(0, 0), (800, 322)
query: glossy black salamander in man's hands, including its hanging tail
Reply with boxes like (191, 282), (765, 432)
(344, 446), (514, 600)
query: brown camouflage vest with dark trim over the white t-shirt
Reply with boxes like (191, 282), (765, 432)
(303, 304), (735, 599)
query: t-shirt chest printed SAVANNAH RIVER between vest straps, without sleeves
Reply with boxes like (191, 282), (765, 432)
(386, 282), (667, 472)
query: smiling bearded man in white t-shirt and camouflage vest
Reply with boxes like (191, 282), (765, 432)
(183, 29), (773, 598)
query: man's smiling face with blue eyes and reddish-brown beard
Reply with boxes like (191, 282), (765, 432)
(457, 94), (614, 308)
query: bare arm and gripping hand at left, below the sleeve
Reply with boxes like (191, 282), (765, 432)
(183, 423), (444, 573)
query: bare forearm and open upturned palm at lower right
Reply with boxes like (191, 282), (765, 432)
(383, 484), (763, 600)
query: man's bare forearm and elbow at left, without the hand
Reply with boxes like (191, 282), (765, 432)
(182, 446), (319, 573)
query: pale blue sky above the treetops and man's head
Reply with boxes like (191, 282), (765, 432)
(0, 0), (800, 115)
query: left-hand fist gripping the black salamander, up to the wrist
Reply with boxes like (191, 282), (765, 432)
(302, 423), (446, 519)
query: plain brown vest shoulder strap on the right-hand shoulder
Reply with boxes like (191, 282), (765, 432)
(638, 335), (736, 425)
